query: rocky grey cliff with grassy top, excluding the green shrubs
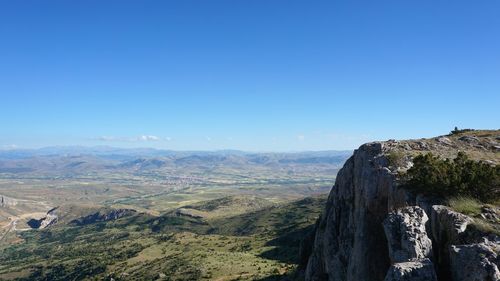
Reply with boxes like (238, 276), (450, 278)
(301, 131), (500, 281)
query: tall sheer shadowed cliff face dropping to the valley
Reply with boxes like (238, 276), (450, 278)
(306, 143), (394, 281)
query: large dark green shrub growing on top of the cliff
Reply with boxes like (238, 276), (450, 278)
(404, 152), (500, 202)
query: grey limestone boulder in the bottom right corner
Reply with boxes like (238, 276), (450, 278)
(450, 243), (500, 281)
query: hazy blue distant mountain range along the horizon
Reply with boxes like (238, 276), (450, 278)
(0, 146), (352, 174)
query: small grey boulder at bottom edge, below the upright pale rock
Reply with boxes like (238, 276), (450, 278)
(384, 259), (437, 281)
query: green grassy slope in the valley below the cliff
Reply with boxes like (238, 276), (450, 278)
(0, 197), (326, 280)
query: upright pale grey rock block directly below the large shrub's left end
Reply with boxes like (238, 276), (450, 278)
(384, 206), (432, 263)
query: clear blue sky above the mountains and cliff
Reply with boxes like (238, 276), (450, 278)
(0, 0), (500, 151)
